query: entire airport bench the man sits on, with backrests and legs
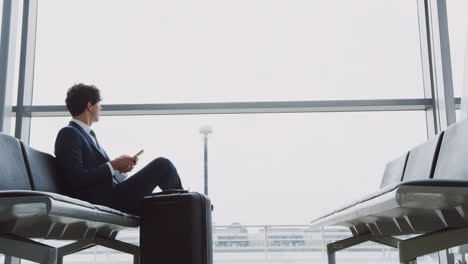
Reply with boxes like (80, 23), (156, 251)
(0, 134), (140, 264)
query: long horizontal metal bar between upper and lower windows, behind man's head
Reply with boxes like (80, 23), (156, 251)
(13, 99), (432, 117)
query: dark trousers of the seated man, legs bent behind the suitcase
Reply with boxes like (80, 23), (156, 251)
(111, 158), (182, 216)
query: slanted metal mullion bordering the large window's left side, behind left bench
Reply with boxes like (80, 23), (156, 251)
(15, 0), (38, 144)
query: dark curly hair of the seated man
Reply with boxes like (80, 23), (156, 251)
(65, 83), (102, 116)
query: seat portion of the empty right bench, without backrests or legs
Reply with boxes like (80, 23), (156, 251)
(311, 180), (468, 235)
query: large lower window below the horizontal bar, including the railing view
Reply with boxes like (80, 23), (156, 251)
(25, 111), (430, 264)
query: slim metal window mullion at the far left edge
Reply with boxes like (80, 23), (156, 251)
(0, 0), (19, 134)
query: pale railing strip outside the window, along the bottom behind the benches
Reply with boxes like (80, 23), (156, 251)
(0, 224), (438, 264)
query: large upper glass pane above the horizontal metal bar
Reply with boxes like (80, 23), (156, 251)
(34, 0), (423, 104)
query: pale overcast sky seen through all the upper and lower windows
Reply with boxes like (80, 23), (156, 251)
(4, 0), (468, 224)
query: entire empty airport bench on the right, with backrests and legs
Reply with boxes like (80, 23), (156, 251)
(311, 121), (468, 264)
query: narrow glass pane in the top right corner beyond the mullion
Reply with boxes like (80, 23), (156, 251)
(447, 0), (468, 97)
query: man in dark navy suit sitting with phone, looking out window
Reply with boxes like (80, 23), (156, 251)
(55, 83), (182, 215)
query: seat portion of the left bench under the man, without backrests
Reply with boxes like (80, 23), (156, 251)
(0, 191), (139, 240)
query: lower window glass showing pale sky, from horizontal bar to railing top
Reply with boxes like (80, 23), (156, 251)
(31, 111), (426, 225)
